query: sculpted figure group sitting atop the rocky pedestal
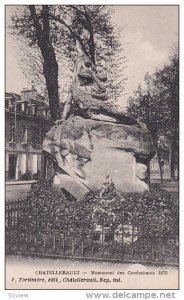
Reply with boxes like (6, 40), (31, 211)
(55, 44), (140, 126)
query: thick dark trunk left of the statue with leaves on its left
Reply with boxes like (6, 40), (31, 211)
(12, 5), (60, 121)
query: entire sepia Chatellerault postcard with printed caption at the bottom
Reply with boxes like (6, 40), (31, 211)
(5, 4), (179, 290)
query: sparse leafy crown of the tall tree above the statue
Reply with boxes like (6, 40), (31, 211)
(10, 5), (125, 105)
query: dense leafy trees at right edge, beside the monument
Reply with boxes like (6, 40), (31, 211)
(127, 52), (179, 181)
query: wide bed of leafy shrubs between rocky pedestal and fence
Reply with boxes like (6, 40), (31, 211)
(20, 179), (178, 235)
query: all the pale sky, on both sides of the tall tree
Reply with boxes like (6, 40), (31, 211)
(6, 5), (178, 106)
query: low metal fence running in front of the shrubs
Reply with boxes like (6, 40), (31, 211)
(5, 200), (178, 266)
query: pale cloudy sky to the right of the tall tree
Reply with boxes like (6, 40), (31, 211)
(110, 5), (178, 106)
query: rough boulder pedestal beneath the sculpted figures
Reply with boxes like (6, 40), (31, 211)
(43, 116), (154, 199)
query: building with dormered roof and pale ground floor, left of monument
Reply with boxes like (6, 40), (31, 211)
(5, 86), (52, 181)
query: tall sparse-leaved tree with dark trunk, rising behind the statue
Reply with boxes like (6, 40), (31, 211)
(11, 5), (126, 121)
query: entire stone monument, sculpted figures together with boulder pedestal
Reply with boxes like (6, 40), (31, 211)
(43, 41), (154, 199)
